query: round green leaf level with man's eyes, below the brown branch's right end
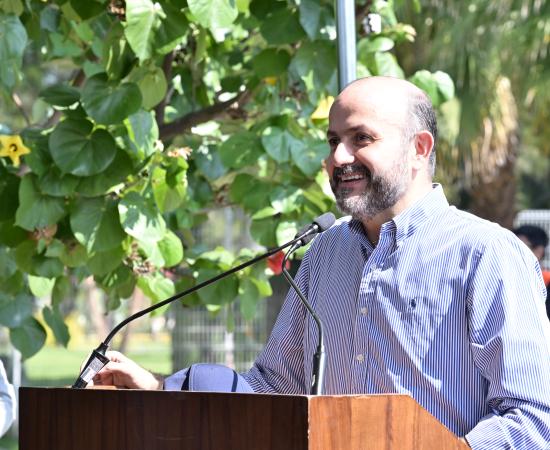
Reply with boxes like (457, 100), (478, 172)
(220, 131), (263, 169)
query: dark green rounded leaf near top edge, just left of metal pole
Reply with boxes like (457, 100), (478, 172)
(260, 8), (306, 45)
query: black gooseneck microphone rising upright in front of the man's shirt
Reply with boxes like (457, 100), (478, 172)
(281, 213), (336, 395)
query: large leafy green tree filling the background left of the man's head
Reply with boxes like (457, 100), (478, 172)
(0, 0), (458, 357)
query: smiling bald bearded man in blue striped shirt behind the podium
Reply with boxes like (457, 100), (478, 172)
(88, 77), (550, 450)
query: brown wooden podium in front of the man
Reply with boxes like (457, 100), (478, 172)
(19, 388), (468, 450)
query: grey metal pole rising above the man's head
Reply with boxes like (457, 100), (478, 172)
(336, 0), (357, 91)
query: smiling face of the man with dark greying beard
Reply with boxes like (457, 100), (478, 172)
(326, 88), (412, 220)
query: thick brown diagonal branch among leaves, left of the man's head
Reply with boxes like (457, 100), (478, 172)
(159, 90), (250, 141)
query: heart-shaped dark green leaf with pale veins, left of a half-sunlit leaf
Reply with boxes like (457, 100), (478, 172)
(70, 198), (125, 253)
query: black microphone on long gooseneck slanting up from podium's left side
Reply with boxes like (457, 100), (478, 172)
(72, 213), (335, 389)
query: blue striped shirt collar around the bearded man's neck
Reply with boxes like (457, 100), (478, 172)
(349, 183), (449, 248)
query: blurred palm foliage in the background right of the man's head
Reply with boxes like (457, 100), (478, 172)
(398, 0), (550, 218)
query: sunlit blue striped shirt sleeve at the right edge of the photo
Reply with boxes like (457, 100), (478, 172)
(466, 236), (550, 450)
